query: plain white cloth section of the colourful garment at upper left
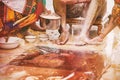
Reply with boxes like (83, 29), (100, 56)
(2, 0), (26, 13)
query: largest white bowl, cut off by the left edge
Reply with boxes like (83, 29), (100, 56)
(0, 37), (20, 49)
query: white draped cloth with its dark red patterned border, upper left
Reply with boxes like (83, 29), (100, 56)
(2, 0), (46, 15)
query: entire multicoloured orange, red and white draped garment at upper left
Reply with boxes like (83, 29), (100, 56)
(0, 0), (46, 36)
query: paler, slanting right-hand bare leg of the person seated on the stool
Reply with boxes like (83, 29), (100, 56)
(80, 0), (98, 42)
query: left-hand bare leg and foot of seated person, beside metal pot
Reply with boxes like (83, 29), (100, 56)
(53, 0), (69, 45)
